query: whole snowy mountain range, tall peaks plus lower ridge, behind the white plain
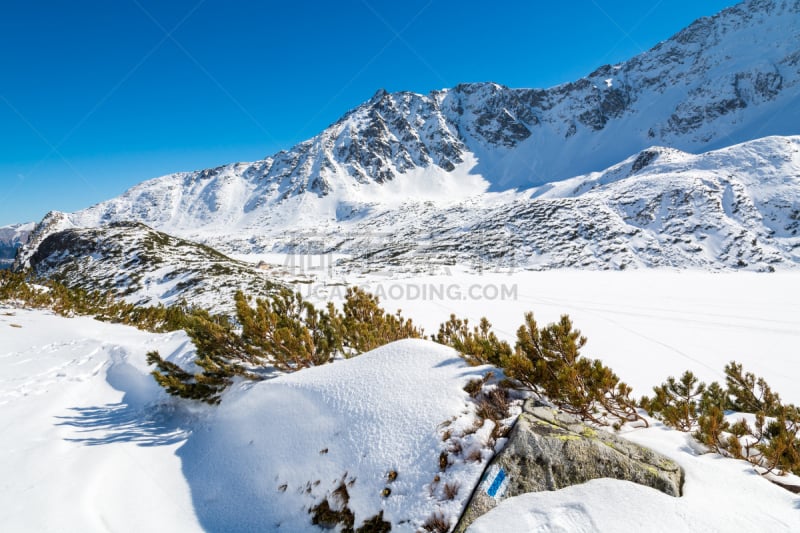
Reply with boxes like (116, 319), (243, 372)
(10, 0), (800, 276)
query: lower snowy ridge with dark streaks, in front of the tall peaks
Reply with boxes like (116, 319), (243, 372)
(26, 136), (800, 279)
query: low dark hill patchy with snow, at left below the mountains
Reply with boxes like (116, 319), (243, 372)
(20, 220), (284, 311)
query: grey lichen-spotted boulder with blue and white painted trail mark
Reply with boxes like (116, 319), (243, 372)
(455, 400), (684, 533)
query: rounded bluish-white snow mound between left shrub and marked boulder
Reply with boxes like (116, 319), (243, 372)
(184, 340), (494, 532)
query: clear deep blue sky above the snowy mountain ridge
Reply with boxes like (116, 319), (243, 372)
(0, 0), (735, 225)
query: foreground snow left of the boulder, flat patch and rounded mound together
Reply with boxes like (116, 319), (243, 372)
(0, 310), (486, 531)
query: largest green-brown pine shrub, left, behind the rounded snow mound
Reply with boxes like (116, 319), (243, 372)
(150, 288), (422, 403)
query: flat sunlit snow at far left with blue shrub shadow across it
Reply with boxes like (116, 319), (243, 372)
(0, 308), (199, 532)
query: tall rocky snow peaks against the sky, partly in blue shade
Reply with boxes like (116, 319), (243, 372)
(62, 0), (800, 225)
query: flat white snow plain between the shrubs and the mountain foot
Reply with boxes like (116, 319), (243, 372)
(330, 269), (800, 404)
